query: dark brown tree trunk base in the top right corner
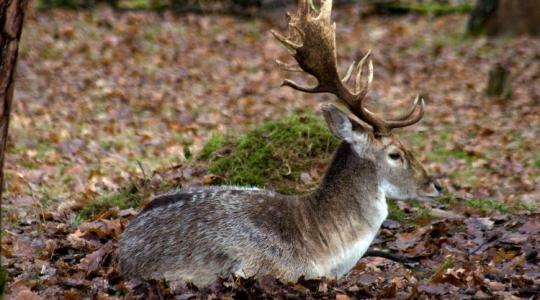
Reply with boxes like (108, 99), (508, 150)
(467, 0), (540, 36)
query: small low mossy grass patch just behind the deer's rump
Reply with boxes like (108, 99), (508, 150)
(77, 184), (143, 219)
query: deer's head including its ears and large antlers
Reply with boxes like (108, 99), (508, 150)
(272, 0), (442, 200)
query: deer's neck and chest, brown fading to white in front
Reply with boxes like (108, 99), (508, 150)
(292, 143), (388, 277)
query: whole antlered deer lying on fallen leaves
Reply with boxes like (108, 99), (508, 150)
(120, 0), (441, 286)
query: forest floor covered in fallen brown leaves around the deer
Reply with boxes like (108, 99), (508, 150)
(1, 2), (540, 299)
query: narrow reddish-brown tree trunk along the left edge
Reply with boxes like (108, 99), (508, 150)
(0, 0), (28, 199)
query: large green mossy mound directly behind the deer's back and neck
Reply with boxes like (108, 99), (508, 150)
(200, 114), (338, 194)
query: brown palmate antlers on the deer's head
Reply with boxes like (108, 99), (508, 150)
(272, 0), (424, 136)
